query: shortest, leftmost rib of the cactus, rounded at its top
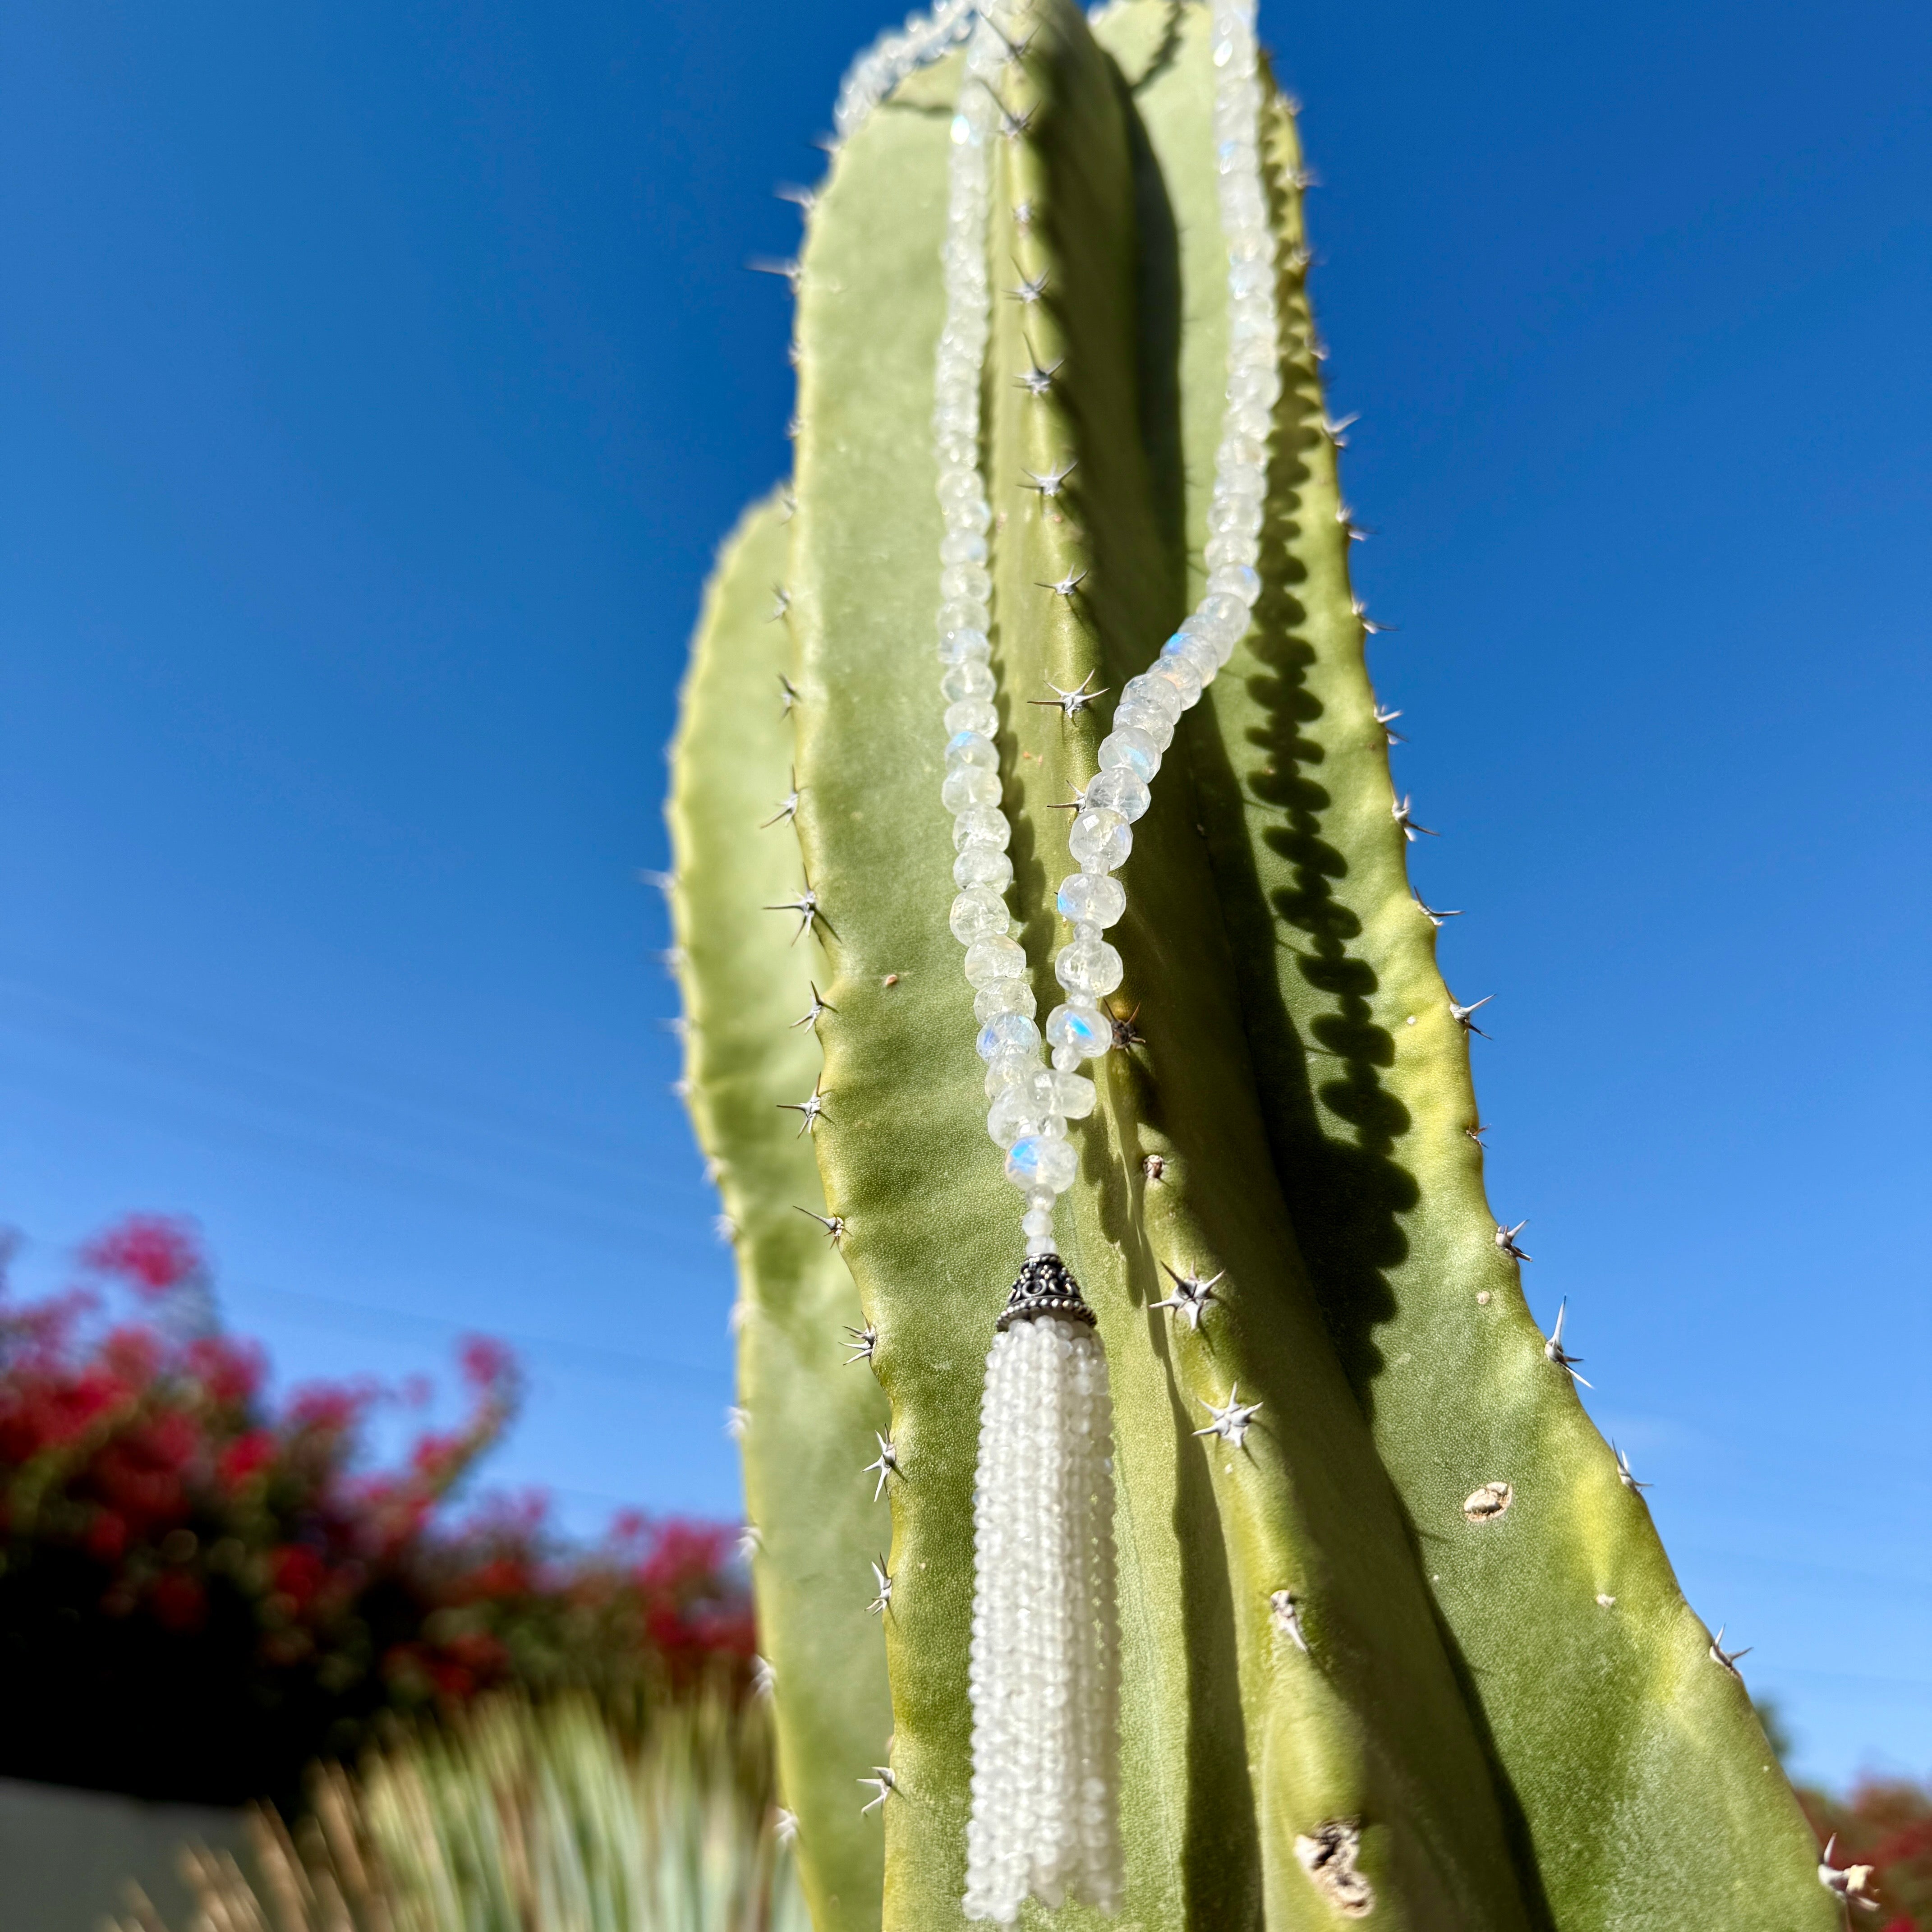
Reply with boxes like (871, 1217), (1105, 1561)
(668, 501), (891, 1932)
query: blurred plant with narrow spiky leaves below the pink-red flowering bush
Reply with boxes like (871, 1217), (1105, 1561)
(120, 1694), (808, 1932)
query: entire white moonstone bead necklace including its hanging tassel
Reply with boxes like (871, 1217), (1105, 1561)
(933, 0), (1281, 1924)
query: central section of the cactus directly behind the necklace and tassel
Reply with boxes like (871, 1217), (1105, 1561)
(792, 8), (1523, 1926)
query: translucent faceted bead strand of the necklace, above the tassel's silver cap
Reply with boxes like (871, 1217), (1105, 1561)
(933, 0), (1281, 1254)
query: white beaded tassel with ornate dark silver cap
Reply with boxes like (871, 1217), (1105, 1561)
(966, 1254), (1121, 1924)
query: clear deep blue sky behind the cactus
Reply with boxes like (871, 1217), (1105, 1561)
(0, 0), (1932, 1776)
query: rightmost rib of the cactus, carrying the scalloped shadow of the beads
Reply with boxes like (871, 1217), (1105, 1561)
(1121, 9), (1837, 1932)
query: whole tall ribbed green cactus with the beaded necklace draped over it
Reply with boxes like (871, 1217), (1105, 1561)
(671, 0), (1837, 1932)
